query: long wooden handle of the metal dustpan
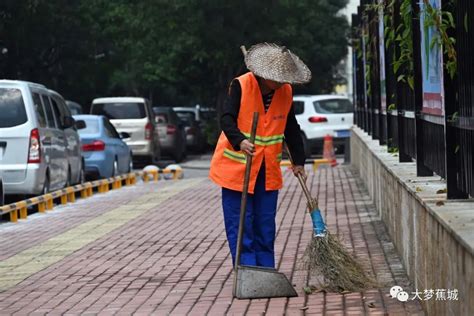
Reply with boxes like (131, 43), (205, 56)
(234, 112), (258, 270)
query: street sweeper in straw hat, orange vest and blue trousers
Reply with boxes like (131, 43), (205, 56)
(209, 43), (311, 268)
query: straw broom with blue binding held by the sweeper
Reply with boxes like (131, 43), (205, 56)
(285, 143), (375, 292)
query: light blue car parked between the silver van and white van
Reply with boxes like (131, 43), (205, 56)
(73, 115), (133, 178)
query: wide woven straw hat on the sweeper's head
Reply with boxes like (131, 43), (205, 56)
(240, 43), (311, 84)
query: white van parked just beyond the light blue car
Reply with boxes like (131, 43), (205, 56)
(91, 97), (161, 164)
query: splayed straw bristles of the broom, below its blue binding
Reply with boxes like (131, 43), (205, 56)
(303, 232), (375, 292)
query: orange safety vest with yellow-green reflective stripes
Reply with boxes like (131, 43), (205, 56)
(209, 72), (292, 194)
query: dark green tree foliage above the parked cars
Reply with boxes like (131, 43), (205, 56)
(0, 0), (348, 110)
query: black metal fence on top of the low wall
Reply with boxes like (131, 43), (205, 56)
(352, 0), (474, 199)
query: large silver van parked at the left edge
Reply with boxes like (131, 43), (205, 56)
(0, 80), (83, 195)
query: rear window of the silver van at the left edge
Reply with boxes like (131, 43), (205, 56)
(0, 88), (28, 128)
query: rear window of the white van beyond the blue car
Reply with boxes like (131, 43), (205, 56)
(91, 103), (146, 120)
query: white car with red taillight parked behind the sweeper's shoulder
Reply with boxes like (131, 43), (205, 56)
(293, 95), (354, 157)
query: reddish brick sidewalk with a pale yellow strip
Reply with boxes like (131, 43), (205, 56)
(0, 166), (423, 315)
